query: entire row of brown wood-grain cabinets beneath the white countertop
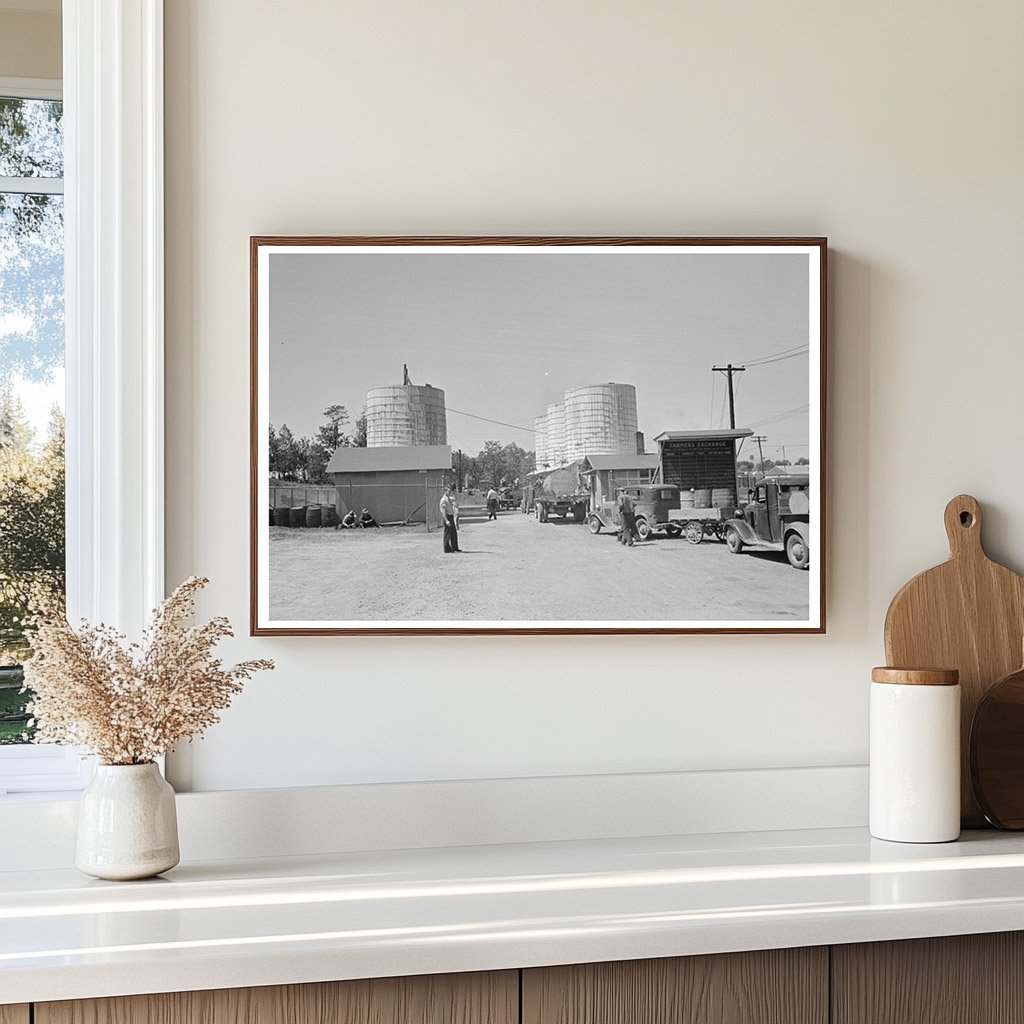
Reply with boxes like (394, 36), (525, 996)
(12, 932), (1024, 1024)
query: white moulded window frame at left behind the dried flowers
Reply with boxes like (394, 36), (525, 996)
(0, 0), (164, 799)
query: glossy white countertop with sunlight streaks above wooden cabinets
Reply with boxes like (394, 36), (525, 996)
(0, 828), (1024, 1004)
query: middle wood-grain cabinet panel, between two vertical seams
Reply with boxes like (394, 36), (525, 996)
(522, 948), (828, 1024)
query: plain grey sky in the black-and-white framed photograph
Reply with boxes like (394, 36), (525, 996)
(269, 250), (816, 458)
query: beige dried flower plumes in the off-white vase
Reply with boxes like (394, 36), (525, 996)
(25, 577), (273, 765)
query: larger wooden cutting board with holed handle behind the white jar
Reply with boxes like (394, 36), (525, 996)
(886, 495), (1024, 828)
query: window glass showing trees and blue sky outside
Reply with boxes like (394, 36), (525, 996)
(0, 97), (65, 744)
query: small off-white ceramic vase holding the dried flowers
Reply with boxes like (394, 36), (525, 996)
(75, 762), (180, 882)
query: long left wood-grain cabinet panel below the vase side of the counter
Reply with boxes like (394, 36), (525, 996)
(36, 971), (519, 1024)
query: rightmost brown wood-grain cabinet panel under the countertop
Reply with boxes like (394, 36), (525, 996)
(831, 932), (1024, 1024)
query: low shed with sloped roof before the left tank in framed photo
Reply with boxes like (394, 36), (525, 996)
(327, 444), (452, 526)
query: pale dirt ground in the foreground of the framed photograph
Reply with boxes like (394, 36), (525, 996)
(269, 512), (809, 622)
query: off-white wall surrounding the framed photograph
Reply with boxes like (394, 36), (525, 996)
(167, 0), (1024, 790)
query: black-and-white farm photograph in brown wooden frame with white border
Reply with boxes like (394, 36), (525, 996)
(250, 237), (827, 635)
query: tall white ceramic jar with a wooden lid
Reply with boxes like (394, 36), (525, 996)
(870, 669), (961, 843)
